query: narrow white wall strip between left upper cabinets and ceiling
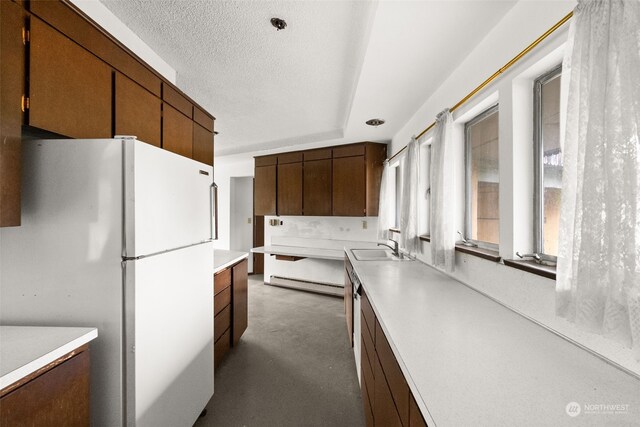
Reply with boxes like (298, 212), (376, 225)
(71, 0), (176, 84)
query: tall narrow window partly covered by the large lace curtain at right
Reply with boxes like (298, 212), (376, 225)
(533, 67), (562, 256)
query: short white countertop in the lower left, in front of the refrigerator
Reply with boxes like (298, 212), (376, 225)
(0, 326), (98, 390)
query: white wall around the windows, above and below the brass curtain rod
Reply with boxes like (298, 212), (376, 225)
(391, 1), (640, 374)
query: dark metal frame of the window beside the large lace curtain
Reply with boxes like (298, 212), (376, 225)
(533, 64), (562, 261)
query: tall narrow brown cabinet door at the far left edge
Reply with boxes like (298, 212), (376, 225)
(0, 1), (25, 227)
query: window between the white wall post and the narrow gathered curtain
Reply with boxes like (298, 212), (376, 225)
(465, 105), (500, 249)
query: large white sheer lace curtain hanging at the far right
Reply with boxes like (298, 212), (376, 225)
(556, 0), (640, 359)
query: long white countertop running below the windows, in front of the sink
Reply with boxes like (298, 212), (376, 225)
(346, 250), (640, 427)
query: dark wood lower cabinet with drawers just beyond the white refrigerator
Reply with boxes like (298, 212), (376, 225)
(213, 259), (249, 368)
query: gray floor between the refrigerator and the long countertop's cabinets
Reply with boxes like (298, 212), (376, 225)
(195, 276), (364, 427)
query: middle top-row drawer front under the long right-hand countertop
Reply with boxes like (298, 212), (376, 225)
(376, 320), (409, 426)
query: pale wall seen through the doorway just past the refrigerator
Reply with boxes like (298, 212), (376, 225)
(229, 176), (253, 271)
